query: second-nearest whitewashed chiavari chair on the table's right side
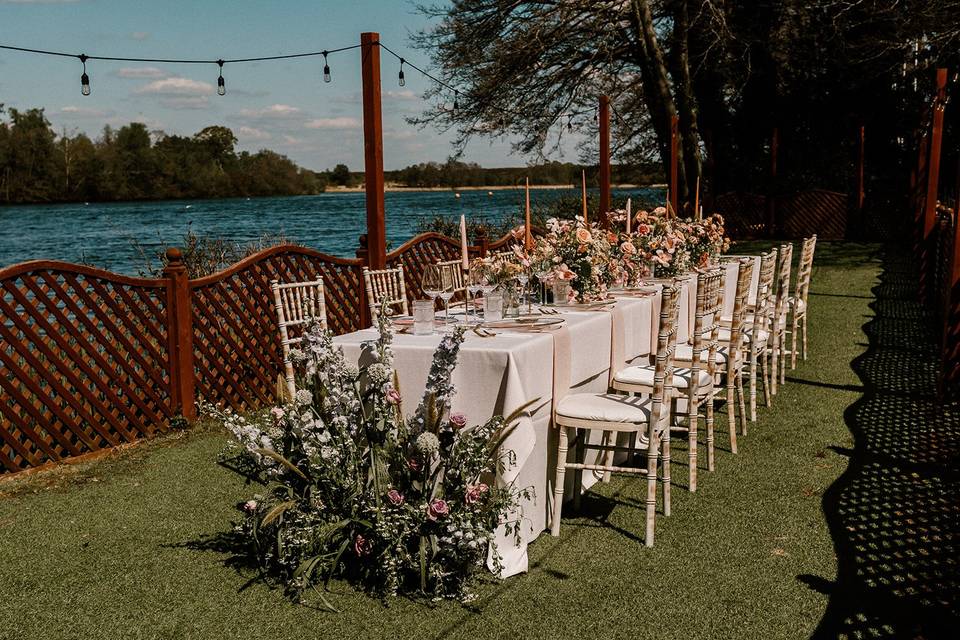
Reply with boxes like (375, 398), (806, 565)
(612, 269), (725, 491)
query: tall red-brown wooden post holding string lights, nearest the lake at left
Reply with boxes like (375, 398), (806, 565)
(360, 32), (387, 269)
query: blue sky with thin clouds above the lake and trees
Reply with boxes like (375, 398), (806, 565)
(0, 0), (576, 170)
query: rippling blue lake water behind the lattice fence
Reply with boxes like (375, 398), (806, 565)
(0, 188), (664, 275)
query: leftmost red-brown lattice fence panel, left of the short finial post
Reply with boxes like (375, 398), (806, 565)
(0, 261), (172, 472)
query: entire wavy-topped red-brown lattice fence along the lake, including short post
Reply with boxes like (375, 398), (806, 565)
(0, 228), (513, 473)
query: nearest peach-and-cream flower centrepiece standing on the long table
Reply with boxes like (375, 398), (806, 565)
(535, 218), (620, 302)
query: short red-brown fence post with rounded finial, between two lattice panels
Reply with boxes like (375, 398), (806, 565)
(163, 247), (197, 420)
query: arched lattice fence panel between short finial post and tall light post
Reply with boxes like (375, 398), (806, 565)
(190, 245), (365, 411)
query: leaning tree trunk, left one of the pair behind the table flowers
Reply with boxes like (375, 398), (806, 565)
(630, 0), (684, 197)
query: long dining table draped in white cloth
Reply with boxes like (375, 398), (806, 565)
(335, 261), (758, 577)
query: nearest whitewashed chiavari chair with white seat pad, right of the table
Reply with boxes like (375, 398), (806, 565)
(550, 285), (680, 547)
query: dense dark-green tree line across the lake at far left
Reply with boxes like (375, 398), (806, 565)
(0, 105), (326, 203)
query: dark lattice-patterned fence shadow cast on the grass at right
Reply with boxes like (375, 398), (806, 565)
(797, 247), (960, 638)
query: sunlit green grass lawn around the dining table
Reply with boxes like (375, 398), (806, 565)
(0, 243), (880, 639)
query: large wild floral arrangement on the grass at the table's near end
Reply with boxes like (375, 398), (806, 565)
(205, 314), (529, 609)
